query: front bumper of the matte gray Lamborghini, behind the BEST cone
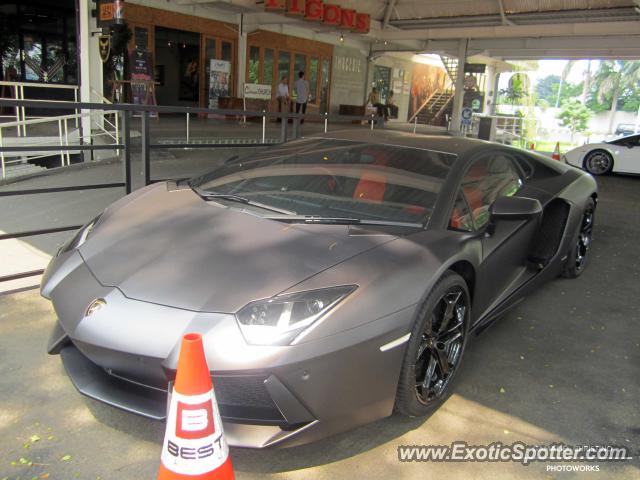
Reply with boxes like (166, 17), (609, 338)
(43, 253), (415, 448)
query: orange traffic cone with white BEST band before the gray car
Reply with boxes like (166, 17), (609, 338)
(158, 333), (235, 480)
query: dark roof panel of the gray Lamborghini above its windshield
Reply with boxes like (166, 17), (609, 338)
(304, 129), (497, 157)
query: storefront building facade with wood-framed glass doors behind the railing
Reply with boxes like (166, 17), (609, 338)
(0, 0), (460, 121)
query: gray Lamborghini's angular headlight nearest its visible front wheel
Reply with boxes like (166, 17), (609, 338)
(236, 285), (357, 345)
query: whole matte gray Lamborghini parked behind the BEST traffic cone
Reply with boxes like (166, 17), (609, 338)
(42, 130), (597, 447)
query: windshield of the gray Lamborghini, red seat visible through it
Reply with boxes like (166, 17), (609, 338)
(191, 139), (455, 224)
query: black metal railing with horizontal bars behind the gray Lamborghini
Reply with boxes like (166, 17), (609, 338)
(0, 99), (384, 288)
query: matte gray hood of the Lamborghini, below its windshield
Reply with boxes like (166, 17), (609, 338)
(80, 184), (395, 313)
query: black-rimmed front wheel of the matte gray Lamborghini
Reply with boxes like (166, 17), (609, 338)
(395, 271), (471, 417)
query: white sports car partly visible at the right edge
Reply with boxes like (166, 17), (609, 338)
(563, 134), (640, 175)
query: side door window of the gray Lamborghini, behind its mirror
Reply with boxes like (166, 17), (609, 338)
(462, 153), (522, 229)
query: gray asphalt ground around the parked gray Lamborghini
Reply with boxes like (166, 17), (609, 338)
(0, 172), (640, 480)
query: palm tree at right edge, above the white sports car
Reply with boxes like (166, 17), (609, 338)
(593, 60), (640, 133)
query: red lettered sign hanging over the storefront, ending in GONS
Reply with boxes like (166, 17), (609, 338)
(264, 0), (371, 34)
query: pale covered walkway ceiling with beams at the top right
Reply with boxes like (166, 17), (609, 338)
(174, 0), (640, 59)
